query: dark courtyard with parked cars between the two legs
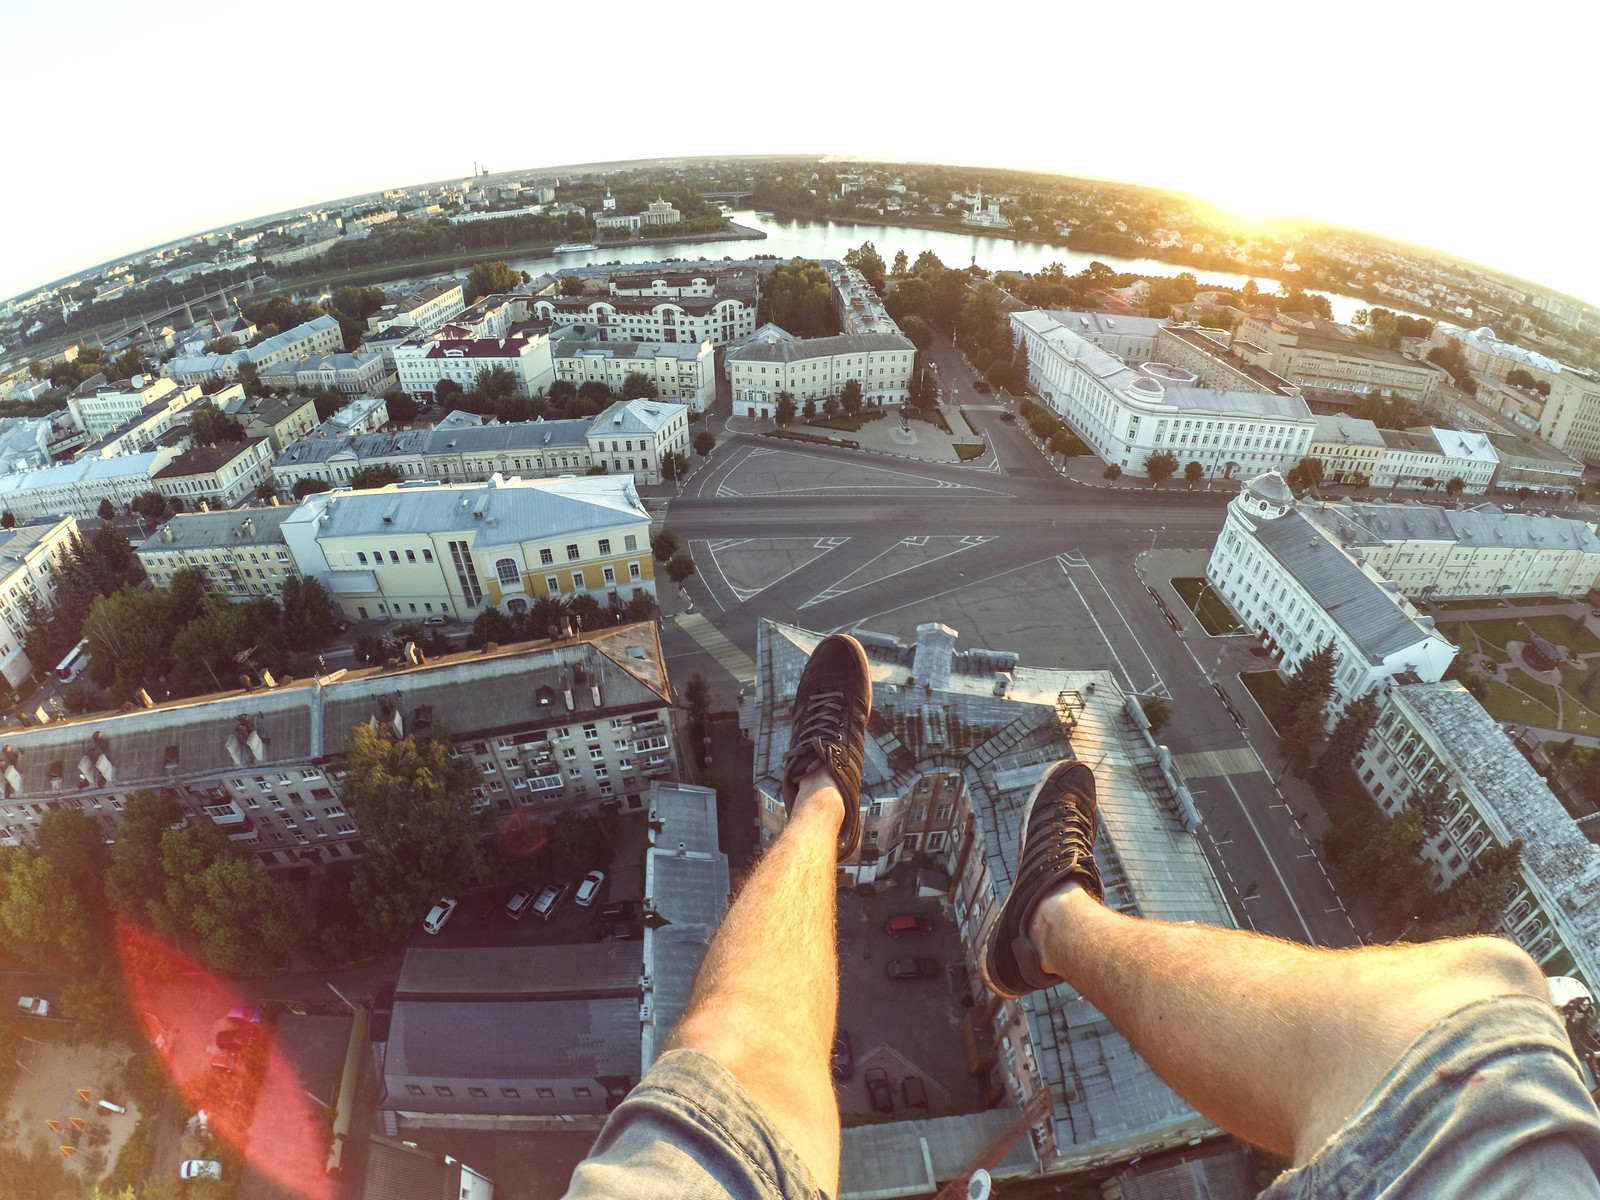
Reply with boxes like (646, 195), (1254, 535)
(837, 886), (984, 1114)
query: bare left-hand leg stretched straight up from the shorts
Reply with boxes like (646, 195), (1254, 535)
(667, 768), (845, 1195)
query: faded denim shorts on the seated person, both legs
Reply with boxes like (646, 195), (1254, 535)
(566, 995), (1600, 1200)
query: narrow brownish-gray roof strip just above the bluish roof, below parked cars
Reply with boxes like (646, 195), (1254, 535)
(395, 942), (640, 1000)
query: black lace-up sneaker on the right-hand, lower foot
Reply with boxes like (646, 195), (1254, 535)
(978, 758), (1106, 997)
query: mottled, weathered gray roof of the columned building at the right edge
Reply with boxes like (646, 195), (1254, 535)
(1398, 682), (1600, 984)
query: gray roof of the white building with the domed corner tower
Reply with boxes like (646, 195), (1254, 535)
(1256, 512), (1438, 662)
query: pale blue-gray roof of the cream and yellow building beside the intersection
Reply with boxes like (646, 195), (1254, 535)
(317, 476), (650, 546)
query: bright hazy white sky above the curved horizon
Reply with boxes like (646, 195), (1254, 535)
(0, 0), (1600, 310)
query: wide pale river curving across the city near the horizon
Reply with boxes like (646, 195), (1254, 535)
(384, 210), (1402, 322)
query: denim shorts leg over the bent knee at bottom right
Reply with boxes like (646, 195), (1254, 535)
(1261, 995), (1600, 1200)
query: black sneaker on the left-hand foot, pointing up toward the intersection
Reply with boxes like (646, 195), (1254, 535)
(784, 634), (872, 862)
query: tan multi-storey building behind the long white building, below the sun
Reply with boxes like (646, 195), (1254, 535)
(1230, 309), (1440, 403)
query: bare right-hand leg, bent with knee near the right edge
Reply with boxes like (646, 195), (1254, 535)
(1030, 883), (1549, 1165)
